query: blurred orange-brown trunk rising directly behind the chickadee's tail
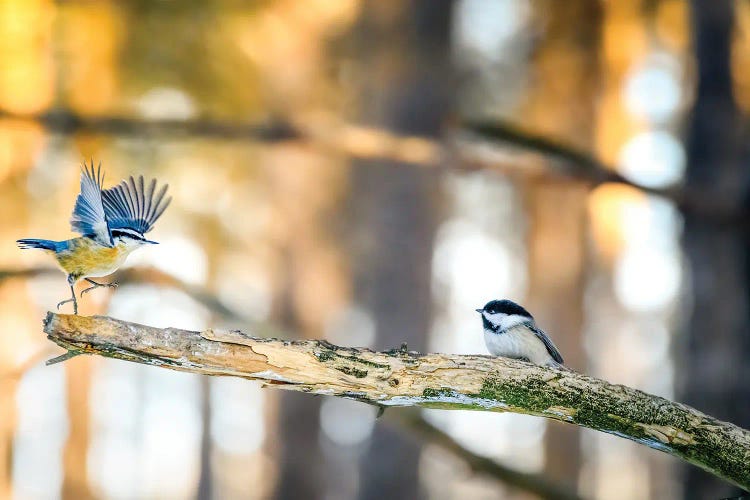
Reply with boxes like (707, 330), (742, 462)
(524, 0), (603, 489)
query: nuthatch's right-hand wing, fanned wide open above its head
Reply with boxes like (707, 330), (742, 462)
(102, 176), (172, 234)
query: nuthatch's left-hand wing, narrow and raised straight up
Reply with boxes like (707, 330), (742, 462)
(70, 161), (113, 247)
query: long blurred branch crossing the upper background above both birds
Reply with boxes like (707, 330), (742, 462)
(0, 109), (747, 223)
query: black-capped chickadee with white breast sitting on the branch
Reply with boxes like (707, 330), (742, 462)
(476, 300), (564, 368)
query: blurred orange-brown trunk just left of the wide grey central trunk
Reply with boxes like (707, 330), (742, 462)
(266, 145), (350, 499)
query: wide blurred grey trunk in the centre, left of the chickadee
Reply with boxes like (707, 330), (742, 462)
(350, 0), (453, 500)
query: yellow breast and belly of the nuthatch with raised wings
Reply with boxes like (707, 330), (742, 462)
(56, 237), (130, 280)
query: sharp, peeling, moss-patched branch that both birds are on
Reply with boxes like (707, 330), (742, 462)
(44, 313), (750, 489)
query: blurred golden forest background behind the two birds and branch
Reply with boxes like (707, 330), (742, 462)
(0, 0), (750, 499)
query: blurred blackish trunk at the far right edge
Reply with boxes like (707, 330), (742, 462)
(680, 0), (750, 499)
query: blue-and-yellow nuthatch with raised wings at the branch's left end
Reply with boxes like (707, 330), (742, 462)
(16, 161), (172, 314)
